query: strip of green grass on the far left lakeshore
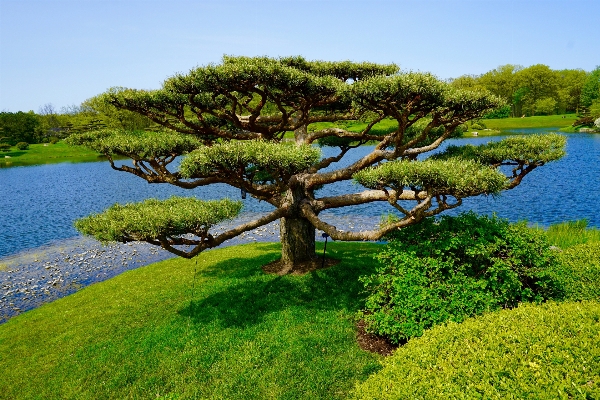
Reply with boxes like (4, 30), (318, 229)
(0, 142), (106, 167)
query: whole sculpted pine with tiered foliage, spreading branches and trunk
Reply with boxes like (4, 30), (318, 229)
(70, 57), (565, 272)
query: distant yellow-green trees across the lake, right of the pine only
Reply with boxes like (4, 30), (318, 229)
(451, 64), (600, 118)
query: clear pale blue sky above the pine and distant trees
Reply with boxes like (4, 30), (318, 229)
(0, 0), (600, 112)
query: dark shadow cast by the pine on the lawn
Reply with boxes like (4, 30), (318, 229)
(179, 242), (376, 328)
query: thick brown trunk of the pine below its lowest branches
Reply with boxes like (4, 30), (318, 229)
(279, 217), (316, 272)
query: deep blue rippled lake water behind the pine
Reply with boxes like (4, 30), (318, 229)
(0, 129), (600, 257)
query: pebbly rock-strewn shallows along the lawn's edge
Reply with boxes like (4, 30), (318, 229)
(0, 214), (378, 323)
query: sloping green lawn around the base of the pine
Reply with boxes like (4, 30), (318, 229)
(0, 243), (381, 399)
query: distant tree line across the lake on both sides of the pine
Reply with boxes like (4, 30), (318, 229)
(0, 64), (600, 146)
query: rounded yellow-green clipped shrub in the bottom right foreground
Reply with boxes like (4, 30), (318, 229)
(351, 301), (600, 400)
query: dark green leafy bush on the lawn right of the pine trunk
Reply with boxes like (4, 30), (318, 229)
(360, 212), (561, 343)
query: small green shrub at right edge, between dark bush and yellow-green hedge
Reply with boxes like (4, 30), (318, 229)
(555, 242), (600, 300)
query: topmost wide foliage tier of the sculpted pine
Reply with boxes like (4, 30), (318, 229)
(103, 57), (499, 139)
